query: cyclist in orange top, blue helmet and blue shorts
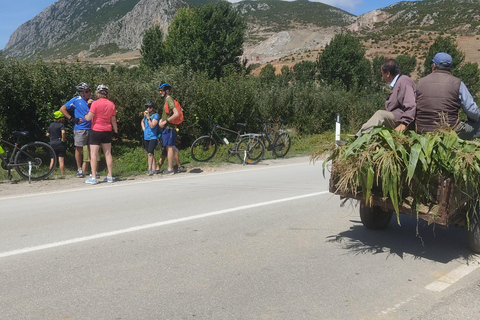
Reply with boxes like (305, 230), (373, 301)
(158, 82), (179, 175)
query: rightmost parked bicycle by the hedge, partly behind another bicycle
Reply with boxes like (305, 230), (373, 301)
(259, 120), (291, 158)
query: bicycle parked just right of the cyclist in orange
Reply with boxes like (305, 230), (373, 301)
(190, 116), (265, 165)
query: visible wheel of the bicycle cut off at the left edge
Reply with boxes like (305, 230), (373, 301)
(14, 141), (57, 180)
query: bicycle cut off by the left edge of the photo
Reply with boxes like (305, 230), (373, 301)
(0, 131), (57, 181)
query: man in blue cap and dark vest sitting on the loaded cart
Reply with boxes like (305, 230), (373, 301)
(415, 52), (480, 140)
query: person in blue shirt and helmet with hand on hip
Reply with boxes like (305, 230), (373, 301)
(60, 82), (93, 178)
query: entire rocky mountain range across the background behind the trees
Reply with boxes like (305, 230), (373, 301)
(3, 0), (480, 63)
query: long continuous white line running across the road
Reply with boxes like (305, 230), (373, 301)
(0, 191), (329, 258)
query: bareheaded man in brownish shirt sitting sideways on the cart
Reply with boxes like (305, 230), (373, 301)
(356, 59), (416, 137)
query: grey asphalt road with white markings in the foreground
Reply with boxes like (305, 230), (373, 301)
(0, 158), (480, 320)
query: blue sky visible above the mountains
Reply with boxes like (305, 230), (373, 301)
(0, 0), (418, 49)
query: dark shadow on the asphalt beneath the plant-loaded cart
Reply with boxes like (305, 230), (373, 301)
(327, 214), (474, 263)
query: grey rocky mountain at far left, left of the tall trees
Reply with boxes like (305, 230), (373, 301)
(4, 0), (186, 58)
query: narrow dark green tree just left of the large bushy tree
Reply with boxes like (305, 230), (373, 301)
(140, 25), (165, 70)
